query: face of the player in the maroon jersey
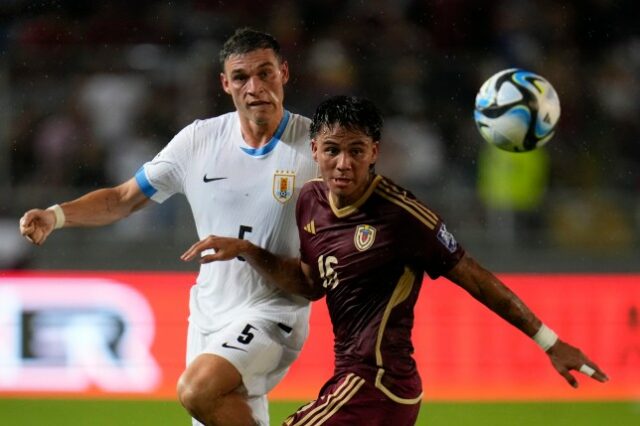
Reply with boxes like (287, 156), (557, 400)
(311, 126), (378, 208)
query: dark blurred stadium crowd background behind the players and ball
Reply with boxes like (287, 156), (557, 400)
(0, 0), (640, 425)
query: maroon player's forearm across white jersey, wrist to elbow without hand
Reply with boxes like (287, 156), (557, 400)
(241, 241), (321, 300)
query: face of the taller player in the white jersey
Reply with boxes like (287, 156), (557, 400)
(220, 49), (289, 125)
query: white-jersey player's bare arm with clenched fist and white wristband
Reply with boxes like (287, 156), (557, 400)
(20, 178), (149, 245)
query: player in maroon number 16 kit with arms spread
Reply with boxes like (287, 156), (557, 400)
(183, 96), (608, 426)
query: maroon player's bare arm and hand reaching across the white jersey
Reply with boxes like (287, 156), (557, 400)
(180, 235), (324, 300)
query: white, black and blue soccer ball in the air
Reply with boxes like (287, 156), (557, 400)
(474, 68), (560, 152)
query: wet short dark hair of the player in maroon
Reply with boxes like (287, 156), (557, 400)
(309, 95), (383, 142)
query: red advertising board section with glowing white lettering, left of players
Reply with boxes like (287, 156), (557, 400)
(0, 272), (194, 398)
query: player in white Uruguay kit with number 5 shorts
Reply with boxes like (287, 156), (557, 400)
(20, 28), (317, 426)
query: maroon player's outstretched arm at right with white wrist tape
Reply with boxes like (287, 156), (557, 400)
(445, 255), (608, 387)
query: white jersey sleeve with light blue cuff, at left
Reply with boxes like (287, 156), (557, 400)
(135, 122), (196, 203)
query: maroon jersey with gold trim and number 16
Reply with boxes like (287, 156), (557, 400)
(296, 176), (464, 403)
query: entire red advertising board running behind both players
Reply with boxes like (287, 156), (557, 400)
(0, 272), (640, 400)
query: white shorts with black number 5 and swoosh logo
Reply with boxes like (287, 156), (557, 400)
(187, 317), (308, 425)
